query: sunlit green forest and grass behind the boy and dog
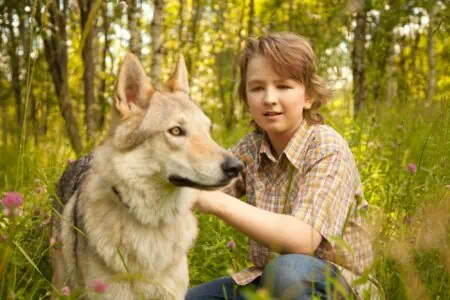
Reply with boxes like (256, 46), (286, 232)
(0, 0), (450, 299)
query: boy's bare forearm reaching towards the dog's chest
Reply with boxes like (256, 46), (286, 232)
(197, 191), (322, 255)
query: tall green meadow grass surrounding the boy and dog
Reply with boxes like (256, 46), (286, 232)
(0, 99), (450, 299)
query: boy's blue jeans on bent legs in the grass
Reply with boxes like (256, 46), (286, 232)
(186, 254), (354, 300)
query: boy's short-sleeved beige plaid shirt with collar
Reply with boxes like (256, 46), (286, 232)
(223, 121), (377, 297)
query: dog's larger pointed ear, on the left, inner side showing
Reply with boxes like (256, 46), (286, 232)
(114, 53), (154, 118)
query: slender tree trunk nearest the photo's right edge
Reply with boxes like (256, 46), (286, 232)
(426, 4), (436, 105)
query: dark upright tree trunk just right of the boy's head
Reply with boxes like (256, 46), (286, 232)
(352, 0), (367, 114)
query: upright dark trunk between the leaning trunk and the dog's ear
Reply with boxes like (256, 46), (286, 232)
(78, 0), (97, 140)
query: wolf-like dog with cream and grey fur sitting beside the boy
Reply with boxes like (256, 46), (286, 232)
(51, 54), (242, 300)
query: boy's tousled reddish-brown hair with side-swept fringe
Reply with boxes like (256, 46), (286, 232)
(238, 32), (332, 124)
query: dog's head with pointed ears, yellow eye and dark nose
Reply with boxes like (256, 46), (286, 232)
(110, 54), (242, 189)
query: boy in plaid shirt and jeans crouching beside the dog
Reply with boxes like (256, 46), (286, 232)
(186, 33), (377, 300)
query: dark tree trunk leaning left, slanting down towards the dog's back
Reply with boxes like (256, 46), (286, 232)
(36, 0), (83, 153)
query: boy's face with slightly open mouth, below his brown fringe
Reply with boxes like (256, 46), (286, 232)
(246, 55), (312, 140)
